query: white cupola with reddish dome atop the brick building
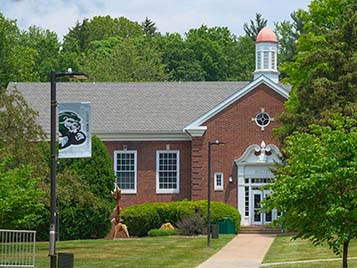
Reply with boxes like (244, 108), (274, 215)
(254, 27), (279, 83)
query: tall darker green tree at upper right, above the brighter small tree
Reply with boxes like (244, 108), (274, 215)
(277, 0), (357, 141)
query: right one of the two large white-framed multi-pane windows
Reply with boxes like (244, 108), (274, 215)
(156, 150), (180, 193)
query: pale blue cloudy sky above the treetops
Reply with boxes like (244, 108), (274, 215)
(0, 0), (310, 38)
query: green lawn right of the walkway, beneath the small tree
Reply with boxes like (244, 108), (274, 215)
(263, 235), (357, 268)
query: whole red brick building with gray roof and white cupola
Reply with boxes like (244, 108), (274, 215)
(13, 28), (290, 225)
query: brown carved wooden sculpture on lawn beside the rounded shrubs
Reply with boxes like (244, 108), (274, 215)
(107, 186), (129, 239)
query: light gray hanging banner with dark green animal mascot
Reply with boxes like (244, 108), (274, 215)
(58, 102), (92, 158)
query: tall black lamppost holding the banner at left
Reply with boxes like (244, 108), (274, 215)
(49, 69), (88, 268)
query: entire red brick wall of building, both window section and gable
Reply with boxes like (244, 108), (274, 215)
(104, 85), (285, 207)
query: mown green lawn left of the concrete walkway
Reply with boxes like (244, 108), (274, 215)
(36, 235), (234, 268)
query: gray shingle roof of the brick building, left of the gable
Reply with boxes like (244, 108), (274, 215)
(8, 82), (290, 134)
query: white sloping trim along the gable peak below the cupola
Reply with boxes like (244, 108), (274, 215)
(184, 75), (289, 133)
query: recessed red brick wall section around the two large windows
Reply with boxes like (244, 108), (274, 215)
(104, 141), (191, 208)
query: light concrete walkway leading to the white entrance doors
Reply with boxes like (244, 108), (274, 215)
(197, 234), (275, 268)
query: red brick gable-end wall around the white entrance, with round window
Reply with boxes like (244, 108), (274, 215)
(192, 85), (285, 207)
